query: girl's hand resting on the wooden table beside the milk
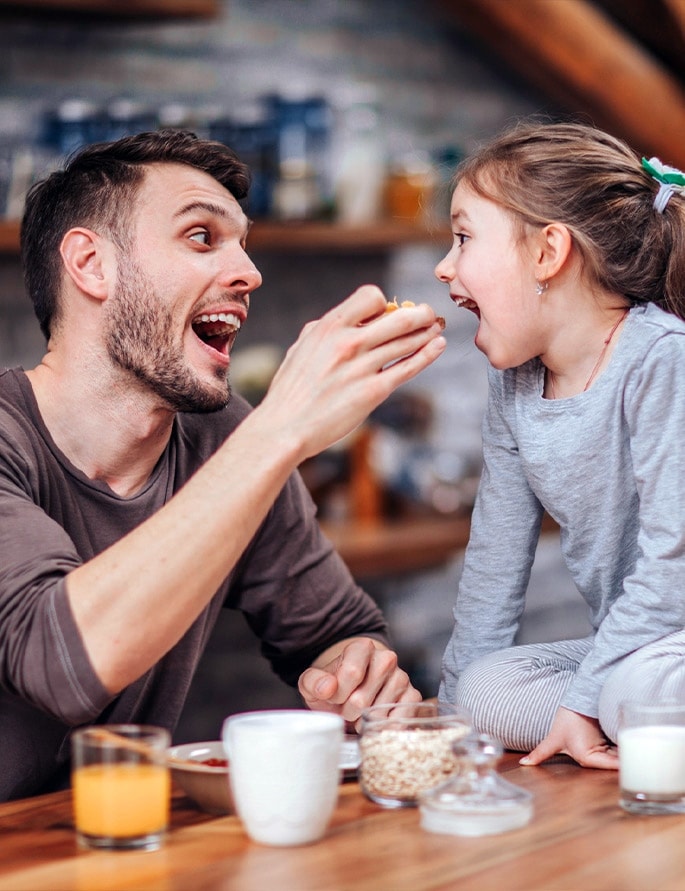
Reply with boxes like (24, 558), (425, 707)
(519, 707), (618, 770)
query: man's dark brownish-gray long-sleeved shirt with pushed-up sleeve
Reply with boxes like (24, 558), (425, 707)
(0, 369), (385, 801)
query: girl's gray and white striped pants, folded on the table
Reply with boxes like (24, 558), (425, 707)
(456, 631), (685, 752)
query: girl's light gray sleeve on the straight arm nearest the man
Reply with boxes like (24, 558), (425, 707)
(439, 368), (543, 702)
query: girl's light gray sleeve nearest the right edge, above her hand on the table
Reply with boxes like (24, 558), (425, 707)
(562, 336), (685, 717)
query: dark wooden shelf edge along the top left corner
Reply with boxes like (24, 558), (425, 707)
(0, 0), (219, 18)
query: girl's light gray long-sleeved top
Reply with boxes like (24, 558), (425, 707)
(440, 304), (685, 717)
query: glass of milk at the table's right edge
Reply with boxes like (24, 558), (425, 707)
(618, 702), (685, 814)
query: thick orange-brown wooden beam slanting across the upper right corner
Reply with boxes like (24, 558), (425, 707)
(439, 0), (685, 168)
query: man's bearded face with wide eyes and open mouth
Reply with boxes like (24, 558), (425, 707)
(105, 164), (261, 411)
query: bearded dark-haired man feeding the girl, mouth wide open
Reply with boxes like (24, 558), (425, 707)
(0, 131), (445, 799)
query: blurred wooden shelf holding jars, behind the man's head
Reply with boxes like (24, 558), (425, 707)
(0, 218), (450, 254)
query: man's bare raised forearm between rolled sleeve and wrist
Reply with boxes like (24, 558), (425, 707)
(67, 412), (298, 693)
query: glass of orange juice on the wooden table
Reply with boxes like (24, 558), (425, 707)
(71, 724), (171, 851)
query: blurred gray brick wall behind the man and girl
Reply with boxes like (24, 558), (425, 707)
(0, 0), (588, 739)
